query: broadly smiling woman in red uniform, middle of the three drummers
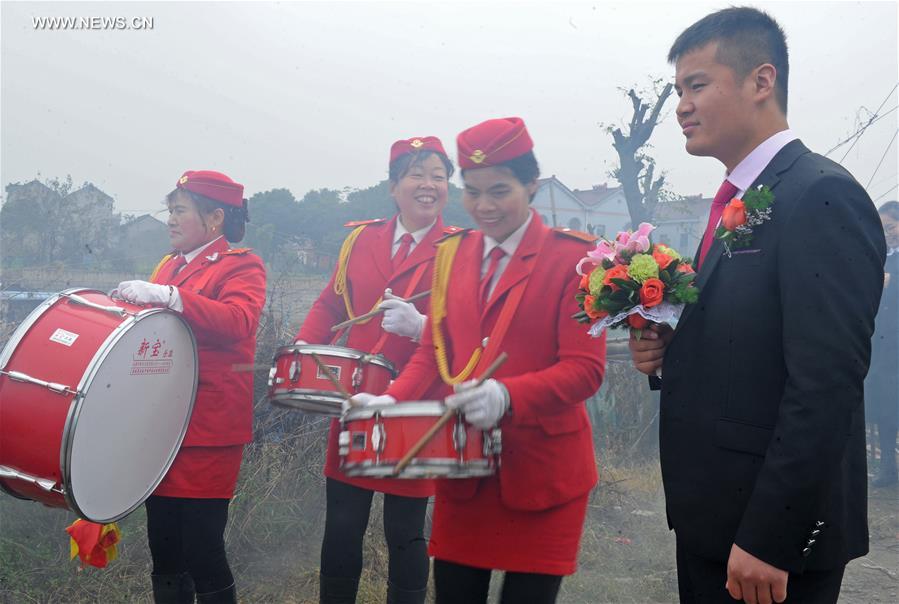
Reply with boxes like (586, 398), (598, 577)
(297, 136), (453, 604)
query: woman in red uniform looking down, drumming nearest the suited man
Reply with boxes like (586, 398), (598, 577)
(387, 118), (605, 604)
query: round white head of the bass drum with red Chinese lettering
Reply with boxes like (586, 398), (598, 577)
(61, 310), (197, 523)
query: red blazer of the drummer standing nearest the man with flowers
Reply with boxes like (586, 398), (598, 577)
(387, 212), (606, 510)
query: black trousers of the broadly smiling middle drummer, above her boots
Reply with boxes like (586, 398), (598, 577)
(321, 478), (428, 591)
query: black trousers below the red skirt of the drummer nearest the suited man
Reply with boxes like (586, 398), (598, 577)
(434, 560), (562, 604)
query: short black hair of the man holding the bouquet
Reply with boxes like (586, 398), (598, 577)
(668, 6), (790, 115)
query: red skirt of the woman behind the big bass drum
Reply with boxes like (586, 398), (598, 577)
(153, 445), (243, 499)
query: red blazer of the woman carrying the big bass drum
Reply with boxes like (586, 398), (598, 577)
(153, 237), (265, 447)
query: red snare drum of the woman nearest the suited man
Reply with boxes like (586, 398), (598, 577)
(338, 401), (501, 478)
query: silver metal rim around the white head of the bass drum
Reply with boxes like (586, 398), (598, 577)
(59, 302), (200, 524)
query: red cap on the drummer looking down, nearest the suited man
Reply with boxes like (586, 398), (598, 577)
(456, 117), (534, 170)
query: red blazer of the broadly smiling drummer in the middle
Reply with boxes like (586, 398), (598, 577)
(296, 216), (444, 497)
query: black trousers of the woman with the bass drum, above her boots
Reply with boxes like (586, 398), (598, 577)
(146, 495), (234, 594)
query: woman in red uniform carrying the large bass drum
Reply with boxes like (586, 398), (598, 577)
(118, 170), (265, 603)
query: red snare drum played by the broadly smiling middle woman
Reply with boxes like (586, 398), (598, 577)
(268, 344), (396, 417)
